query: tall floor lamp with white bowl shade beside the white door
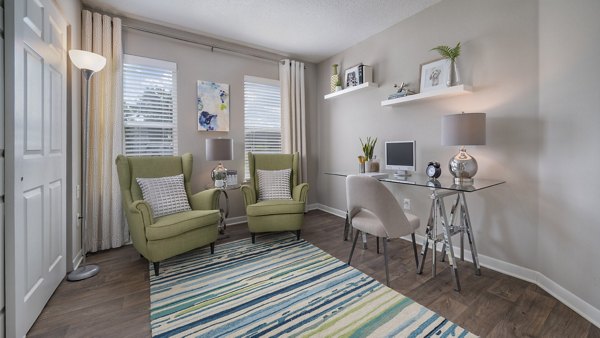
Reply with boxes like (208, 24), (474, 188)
(67, 49), (106, 281)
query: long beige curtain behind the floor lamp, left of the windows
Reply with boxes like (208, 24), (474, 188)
(81, 10), (129, 252)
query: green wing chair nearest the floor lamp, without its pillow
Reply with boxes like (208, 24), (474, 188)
(116, 154), (221, 276)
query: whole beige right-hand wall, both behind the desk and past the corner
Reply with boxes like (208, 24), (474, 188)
(318, 0), (600, 323)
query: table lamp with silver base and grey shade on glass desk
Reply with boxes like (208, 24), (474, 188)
(442, 112), (485, 184)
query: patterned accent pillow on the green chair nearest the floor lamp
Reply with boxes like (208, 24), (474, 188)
(135, 174), (192, 217)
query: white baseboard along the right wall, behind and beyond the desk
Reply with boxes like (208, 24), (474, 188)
(317, 204), (600, 327)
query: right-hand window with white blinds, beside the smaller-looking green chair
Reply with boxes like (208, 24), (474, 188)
(244, 76), (281, 179)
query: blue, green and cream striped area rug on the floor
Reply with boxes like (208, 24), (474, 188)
(150, 233), (473, 337)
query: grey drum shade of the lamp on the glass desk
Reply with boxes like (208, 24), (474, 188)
(442, 113), (485, 146)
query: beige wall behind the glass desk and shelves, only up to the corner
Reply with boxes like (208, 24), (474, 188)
(318, 0), (539, 268)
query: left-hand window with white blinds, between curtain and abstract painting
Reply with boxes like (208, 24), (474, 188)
(123, 55), (177, 155)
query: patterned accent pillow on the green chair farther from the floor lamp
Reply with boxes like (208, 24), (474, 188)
(256, 169), (292, 201)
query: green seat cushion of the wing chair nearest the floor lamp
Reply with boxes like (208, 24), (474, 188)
(146, 210), (221, 241)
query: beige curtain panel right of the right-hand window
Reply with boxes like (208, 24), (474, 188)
(279, 59), (308, 182)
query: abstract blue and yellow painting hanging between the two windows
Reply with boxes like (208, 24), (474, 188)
(197, 81), (229, 131)
